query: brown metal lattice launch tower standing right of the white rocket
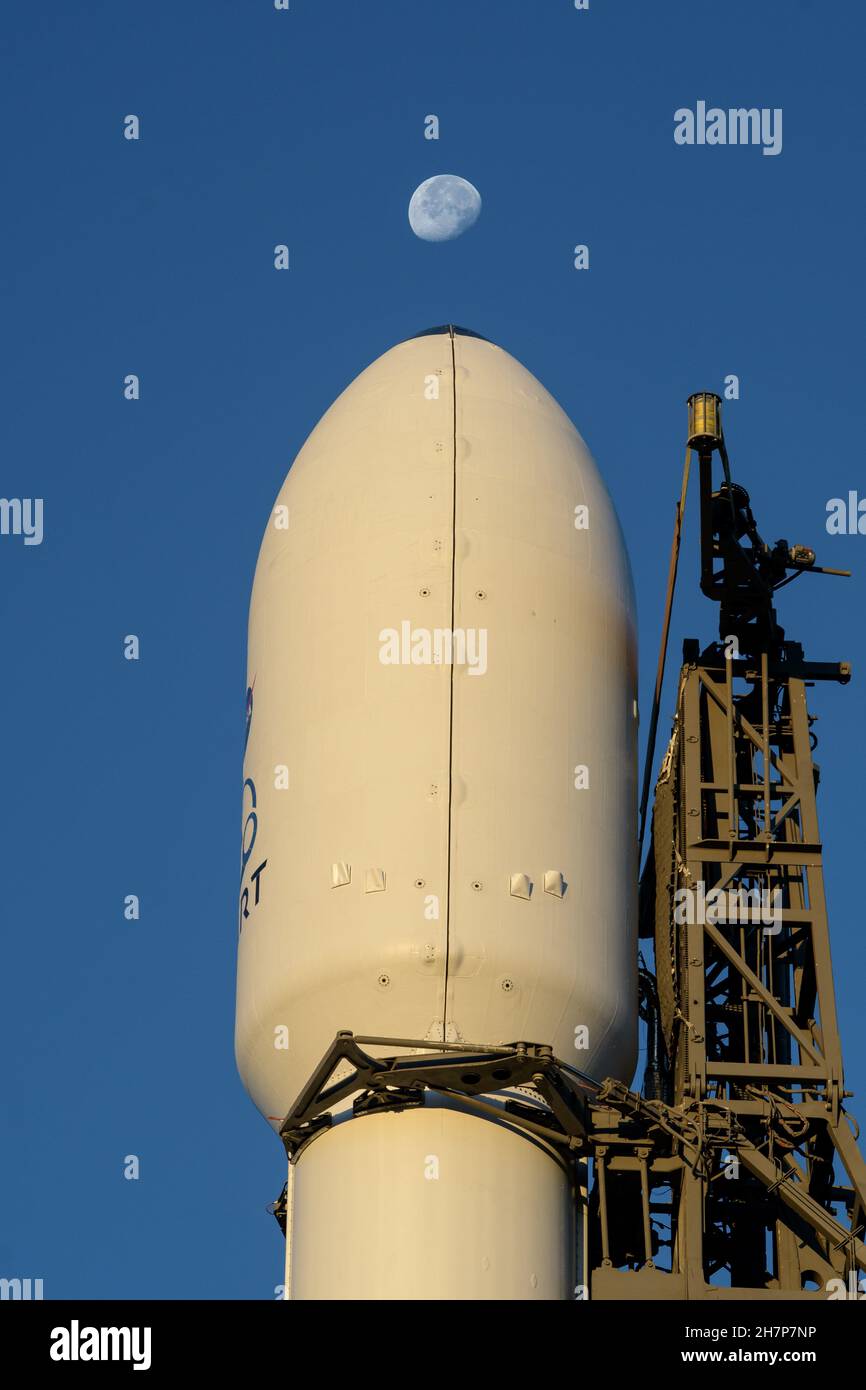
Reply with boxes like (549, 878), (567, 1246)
(588, 395), (866, 1300)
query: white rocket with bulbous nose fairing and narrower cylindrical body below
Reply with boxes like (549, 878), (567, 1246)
(236, 325), (638, 1300)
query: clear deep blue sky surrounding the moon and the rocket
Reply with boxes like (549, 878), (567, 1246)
(0, 0), (866, 1298)
